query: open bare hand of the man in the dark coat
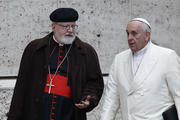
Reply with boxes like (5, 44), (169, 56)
(75, 95), (91, 109)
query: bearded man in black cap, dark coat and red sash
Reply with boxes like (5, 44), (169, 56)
(8, 8), (104, 120)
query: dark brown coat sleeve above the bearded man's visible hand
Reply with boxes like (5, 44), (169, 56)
(82, 47), (104, 112)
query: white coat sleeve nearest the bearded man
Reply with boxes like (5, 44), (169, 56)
(101, 57), (120, 120)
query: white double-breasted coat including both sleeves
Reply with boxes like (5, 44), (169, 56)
(101, 43), (180, 120)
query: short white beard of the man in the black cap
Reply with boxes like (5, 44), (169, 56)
(54, 32), (76, 44)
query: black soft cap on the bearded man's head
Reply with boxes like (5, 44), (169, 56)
(49, 8), (79, 22)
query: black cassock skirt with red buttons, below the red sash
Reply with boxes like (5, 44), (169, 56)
(43, 93), (74, 120)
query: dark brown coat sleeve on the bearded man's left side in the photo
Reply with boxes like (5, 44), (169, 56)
(7, 42), (32, 120)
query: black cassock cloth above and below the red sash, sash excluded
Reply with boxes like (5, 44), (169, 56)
(42, 37), (75, 120)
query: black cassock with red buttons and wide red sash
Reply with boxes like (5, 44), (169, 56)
(43, 38), (75, 120)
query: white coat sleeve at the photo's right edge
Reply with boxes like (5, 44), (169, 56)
(166, 51), (180, 118)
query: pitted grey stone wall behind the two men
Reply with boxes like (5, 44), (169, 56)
(0, 0), (180, 120)
